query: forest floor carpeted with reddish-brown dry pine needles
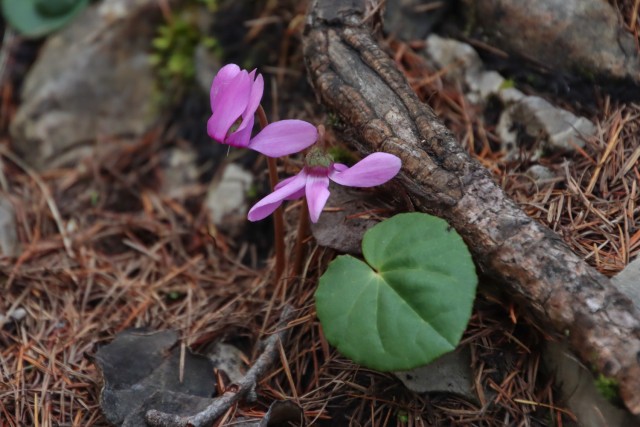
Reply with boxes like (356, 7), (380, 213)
(0, 0), (640, 426)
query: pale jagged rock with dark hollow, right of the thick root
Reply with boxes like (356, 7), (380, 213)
(496, 96), (596, 158)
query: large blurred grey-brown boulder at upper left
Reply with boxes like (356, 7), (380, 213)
(10, 0), (184, 169)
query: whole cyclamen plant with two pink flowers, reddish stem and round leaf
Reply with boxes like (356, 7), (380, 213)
(207, 64), (478, 378)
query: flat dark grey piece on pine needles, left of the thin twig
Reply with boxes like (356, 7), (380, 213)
(94, 328), (217, 427)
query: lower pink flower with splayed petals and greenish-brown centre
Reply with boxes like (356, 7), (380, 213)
(248, 151), (401, 222)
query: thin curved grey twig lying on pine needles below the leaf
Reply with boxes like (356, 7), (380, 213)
(145, 305), (293, 427)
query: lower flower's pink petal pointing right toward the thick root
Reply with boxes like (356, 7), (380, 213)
(329, 153), (402, 187)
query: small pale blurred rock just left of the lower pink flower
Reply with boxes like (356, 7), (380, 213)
(205, 163), (253, 234)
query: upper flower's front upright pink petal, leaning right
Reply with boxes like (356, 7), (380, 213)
(207, 70), (251, 142)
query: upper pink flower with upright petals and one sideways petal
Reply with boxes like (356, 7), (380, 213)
(207, 64), (318, 157)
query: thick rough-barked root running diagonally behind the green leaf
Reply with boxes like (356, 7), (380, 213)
(304, 0), (640, 415)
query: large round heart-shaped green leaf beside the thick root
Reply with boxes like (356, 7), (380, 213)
(315, 213), (477, 371)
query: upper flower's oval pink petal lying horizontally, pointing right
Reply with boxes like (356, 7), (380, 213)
(249, 120), (318, 157)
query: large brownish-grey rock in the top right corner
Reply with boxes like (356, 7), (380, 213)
(463, 0), (640, 83)
